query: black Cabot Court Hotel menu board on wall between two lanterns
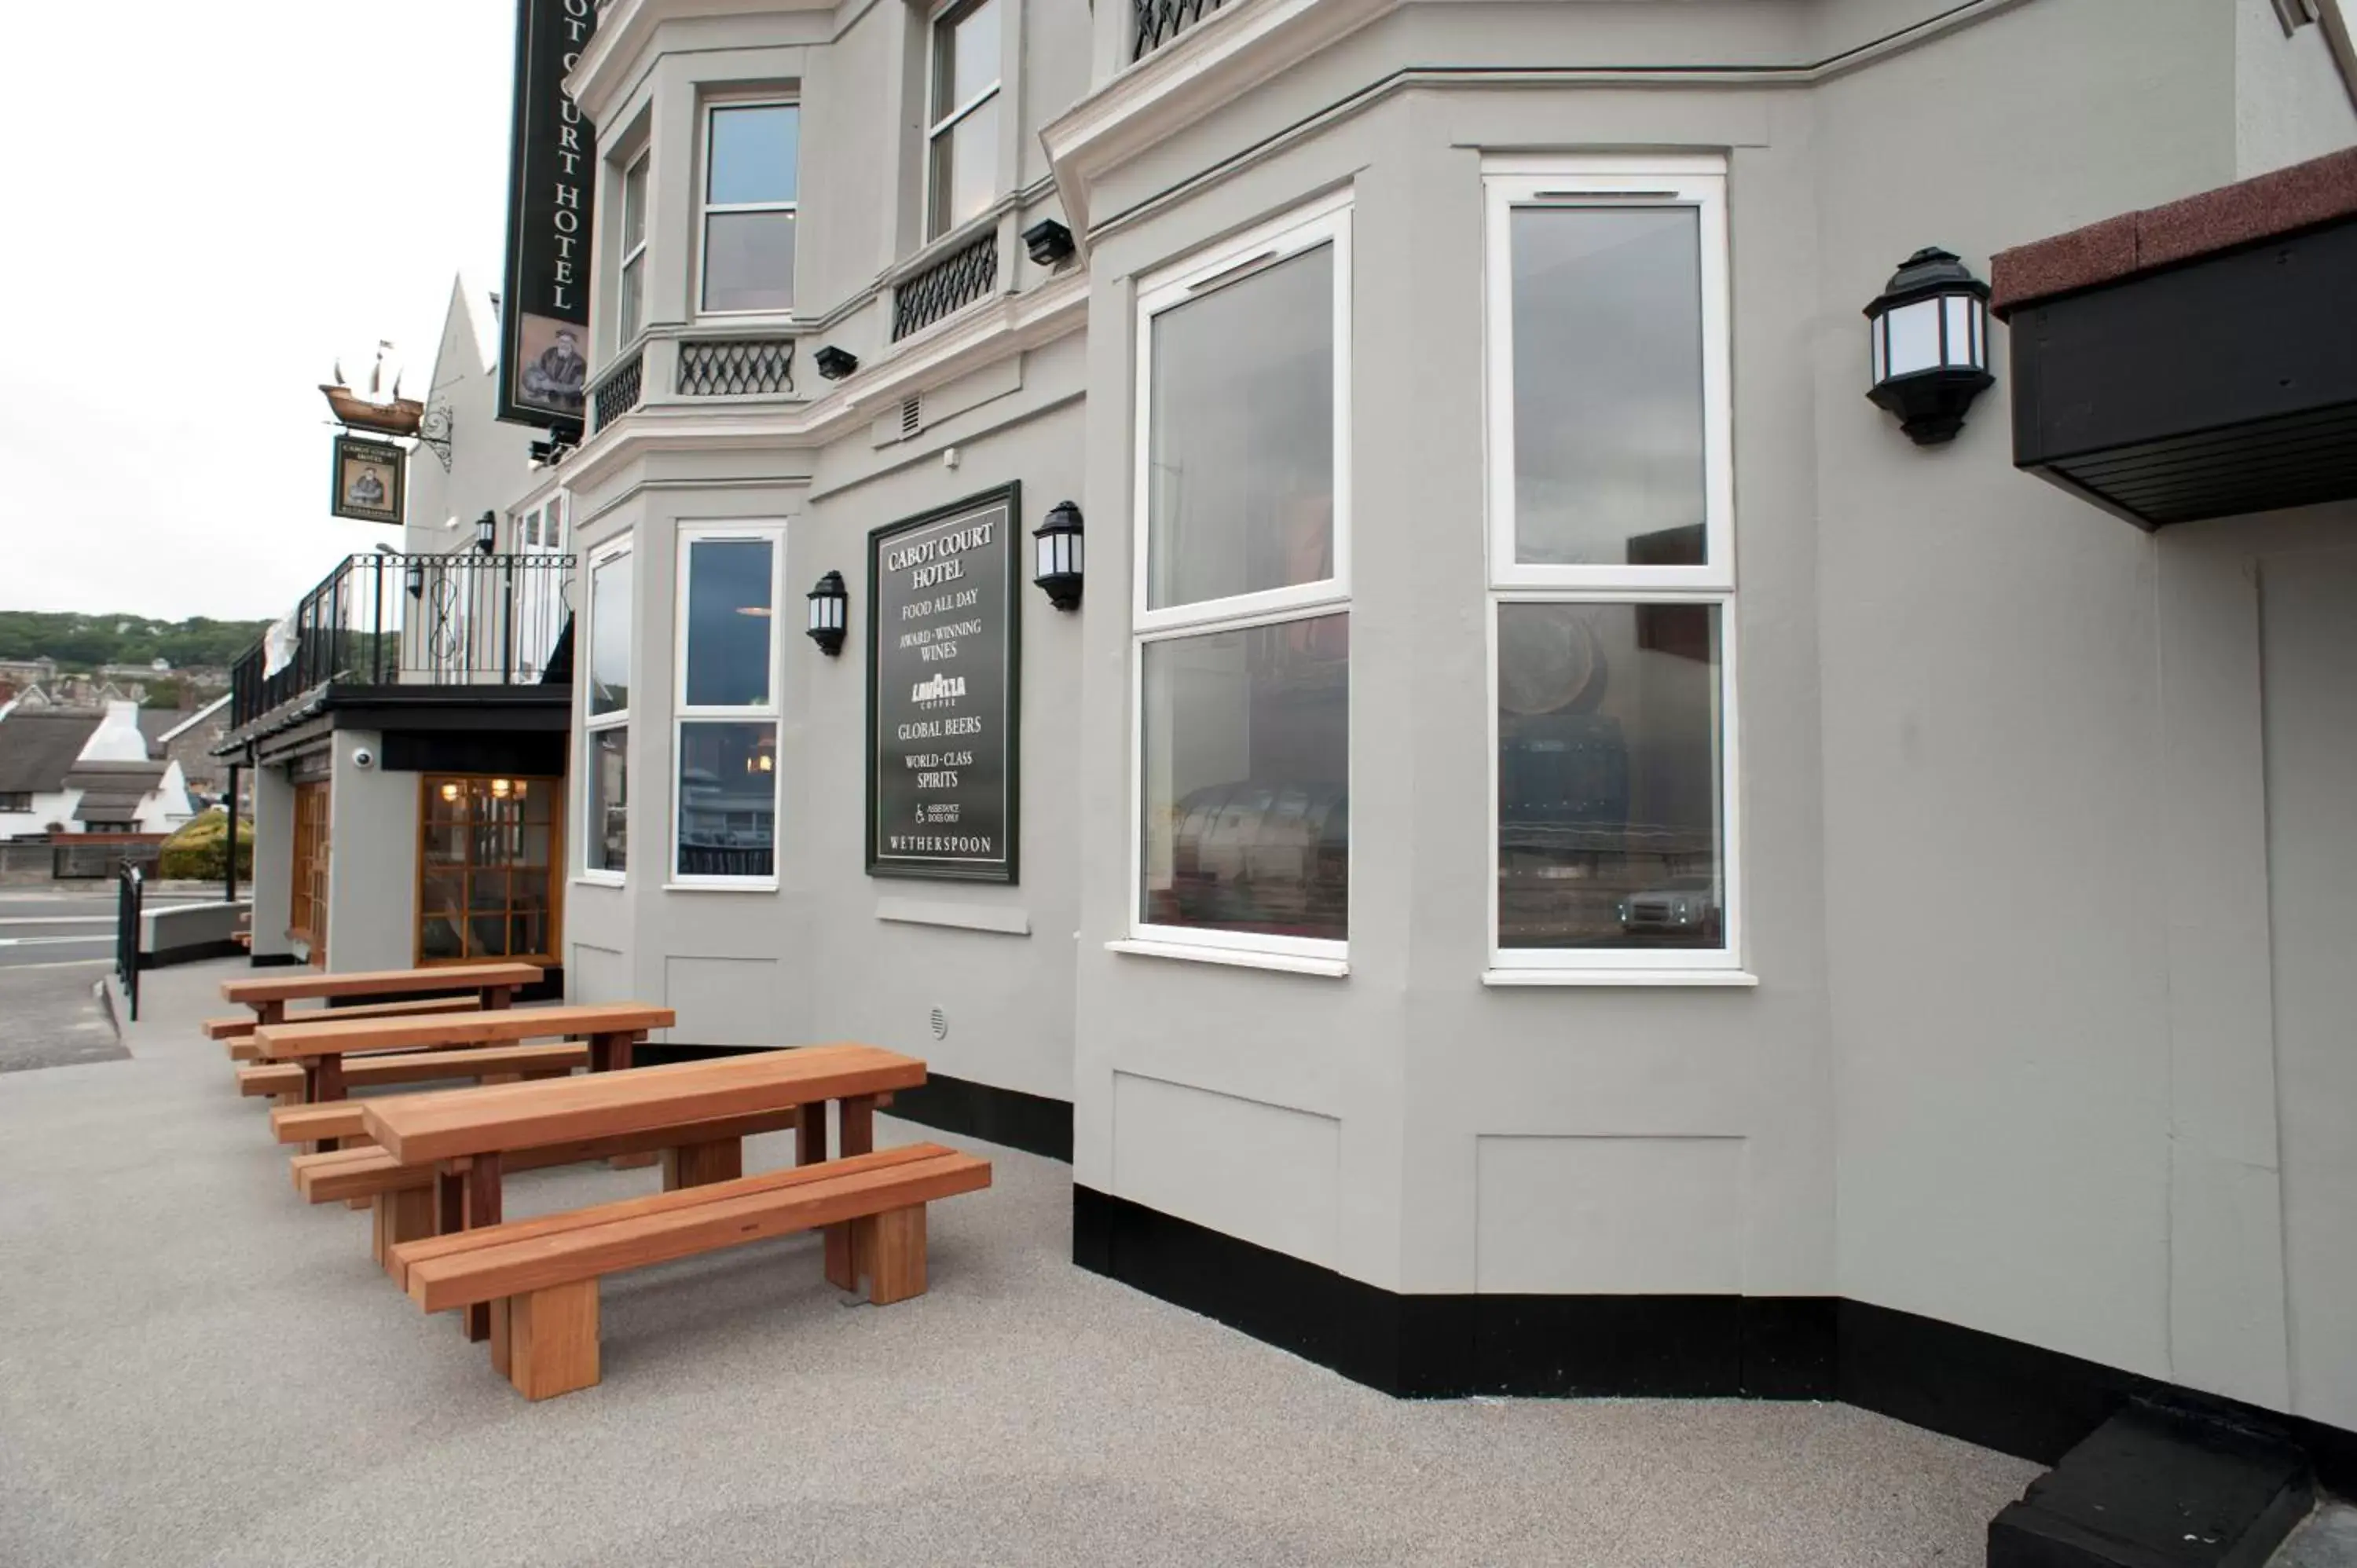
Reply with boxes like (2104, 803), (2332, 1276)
(867, 483), (1023, 882)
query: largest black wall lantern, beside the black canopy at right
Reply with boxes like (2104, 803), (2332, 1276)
(1867, 245), (1996, 445)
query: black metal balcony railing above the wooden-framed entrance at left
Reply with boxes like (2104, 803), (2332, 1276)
(229, 551), (575, 731)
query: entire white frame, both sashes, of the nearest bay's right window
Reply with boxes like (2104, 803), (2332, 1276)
(1483, 156), (1754, 986)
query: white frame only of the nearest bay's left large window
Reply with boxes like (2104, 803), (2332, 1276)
(1110, 189), (1358, 974)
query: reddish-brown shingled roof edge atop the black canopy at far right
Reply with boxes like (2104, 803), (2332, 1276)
(1989, 148), (2357, 318)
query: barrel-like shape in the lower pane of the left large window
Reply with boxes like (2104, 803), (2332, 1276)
(1169, 780), (1351, 941)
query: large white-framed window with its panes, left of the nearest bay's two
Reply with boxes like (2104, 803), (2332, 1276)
(1124, 193), (1351, 974)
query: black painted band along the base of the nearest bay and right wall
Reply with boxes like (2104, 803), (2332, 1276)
(1072, 1184), (2357, 1493)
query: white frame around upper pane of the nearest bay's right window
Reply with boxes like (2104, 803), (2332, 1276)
(1483, 156), (1735, 589)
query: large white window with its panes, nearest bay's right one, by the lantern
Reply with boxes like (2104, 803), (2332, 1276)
(1483, 156), (1749, 984)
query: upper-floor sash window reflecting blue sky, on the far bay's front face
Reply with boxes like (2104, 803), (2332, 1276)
(700, 104), (801, 313)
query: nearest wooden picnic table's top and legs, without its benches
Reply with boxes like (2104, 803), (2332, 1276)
(363, 1045), (924, 1339)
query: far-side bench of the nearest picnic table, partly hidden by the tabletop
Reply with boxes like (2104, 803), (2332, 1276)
(295, 1101), (820, 1266)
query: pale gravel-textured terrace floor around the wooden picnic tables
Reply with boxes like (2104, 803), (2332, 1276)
(0, 965), (2034, 1568)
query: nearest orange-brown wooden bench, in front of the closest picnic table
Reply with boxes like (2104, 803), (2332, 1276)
(391, 1144), (990, 1398)
